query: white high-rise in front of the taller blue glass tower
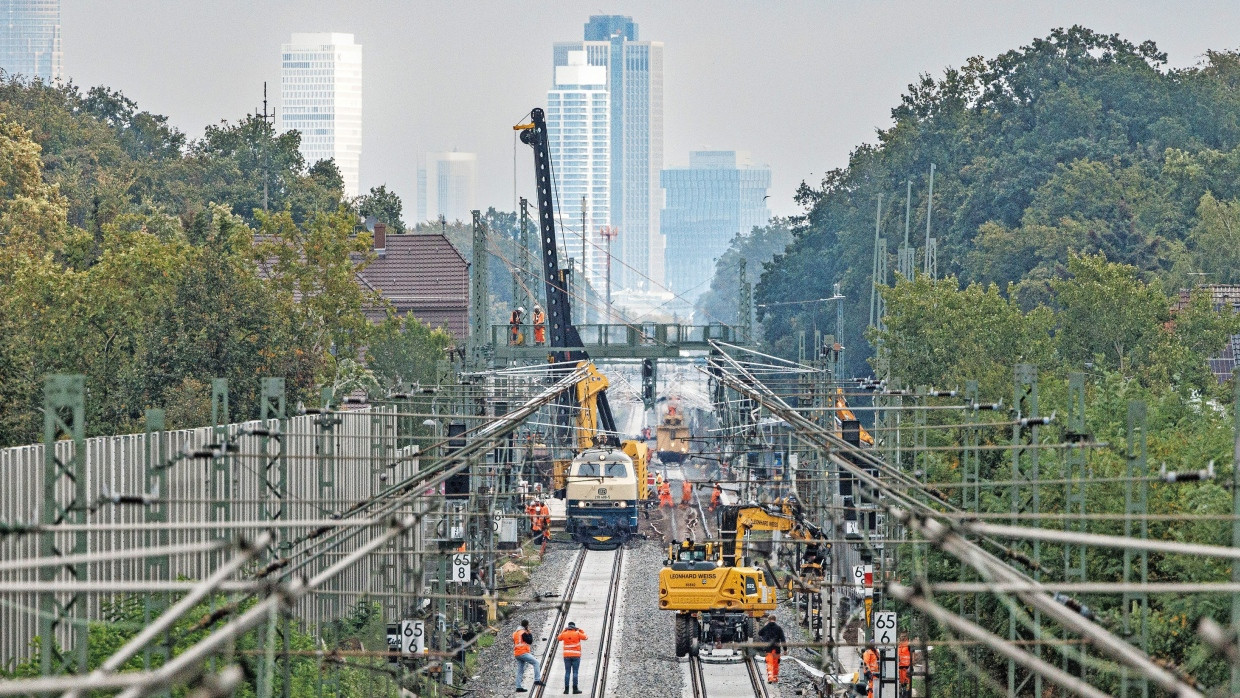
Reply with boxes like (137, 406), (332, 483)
(547, 51), (620, 291)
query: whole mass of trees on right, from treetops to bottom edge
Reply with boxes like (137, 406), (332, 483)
(734, 27), (1240, 694)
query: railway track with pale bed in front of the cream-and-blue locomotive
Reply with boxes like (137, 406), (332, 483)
(531, 547), (624, 698)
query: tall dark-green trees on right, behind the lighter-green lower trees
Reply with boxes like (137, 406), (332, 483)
(756, 27), (1240, 373)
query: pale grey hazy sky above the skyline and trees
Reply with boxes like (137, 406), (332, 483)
(62, 0), (1240, 217)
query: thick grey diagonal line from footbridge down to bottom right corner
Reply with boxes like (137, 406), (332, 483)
(711, 342), (1202, 698)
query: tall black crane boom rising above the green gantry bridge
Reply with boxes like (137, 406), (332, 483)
(515, 107), (619, 443)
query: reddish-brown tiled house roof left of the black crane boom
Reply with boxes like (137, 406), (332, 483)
(360, 233), (469, 345)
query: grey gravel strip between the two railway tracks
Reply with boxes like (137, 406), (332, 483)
(608, 541), (682, 698)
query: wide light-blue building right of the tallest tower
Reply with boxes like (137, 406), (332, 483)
(660, 150), (771, 303)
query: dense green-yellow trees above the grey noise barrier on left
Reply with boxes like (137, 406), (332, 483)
(0, 79), (450, 445)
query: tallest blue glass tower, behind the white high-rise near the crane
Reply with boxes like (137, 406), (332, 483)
(548, 15), (663, 290)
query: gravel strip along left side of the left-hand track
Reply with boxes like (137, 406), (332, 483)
(464, 543), (579, 696)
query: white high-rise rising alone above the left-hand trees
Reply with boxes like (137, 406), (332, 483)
(280, 33), (362, 196)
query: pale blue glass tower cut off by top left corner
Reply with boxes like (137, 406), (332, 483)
(0, 0), (63, 82)
